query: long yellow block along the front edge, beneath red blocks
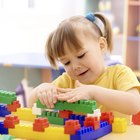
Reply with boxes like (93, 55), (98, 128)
(9, 124), (70, 140)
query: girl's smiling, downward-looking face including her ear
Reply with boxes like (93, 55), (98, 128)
(60, 34), (105, 84)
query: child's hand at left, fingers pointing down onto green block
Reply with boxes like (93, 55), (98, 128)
(34, 83), (57, 108)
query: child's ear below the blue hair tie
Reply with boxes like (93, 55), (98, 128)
(99, 37), (107, 53)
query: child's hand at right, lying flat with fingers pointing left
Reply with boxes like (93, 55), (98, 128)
(57, 81), (93, 102)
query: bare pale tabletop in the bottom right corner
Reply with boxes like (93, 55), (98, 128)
(99, 125), (140, 140)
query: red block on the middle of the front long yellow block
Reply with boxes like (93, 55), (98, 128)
(33, 118), (49, 132)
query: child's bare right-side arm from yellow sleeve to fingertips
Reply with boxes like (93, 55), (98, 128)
(57, 85), (140, 114)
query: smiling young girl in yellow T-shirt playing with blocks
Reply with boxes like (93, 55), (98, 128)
(29, 13), (140, 122)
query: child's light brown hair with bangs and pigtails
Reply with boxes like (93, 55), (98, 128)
(45, 13), (113, 69)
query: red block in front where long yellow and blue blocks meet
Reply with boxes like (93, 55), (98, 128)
(64, 120), (81, 135)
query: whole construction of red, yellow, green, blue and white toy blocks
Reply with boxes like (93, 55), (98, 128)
(0, 90), (127, 140)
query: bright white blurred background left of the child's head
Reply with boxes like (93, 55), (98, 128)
(0, 0), (85, 54)
